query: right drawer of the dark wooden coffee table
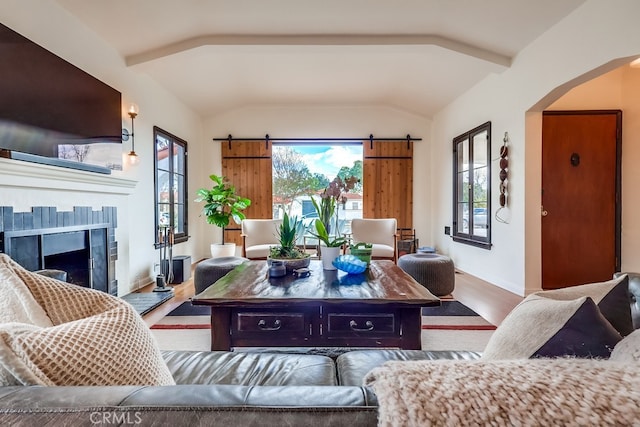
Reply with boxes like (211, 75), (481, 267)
(327, 312), (398, 336)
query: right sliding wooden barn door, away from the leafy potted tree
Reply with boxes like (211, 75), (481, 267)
(362, 141), (413, 229)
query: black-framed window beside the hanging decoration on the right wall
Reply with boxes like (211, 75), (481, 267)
(453, 122), (491, 249)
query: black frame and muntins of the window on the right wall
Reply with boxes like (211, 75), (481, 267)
(452, 121), (491, 250)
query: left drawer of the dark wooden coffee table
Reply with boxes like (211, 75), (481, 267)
(232, 311), (308, 334)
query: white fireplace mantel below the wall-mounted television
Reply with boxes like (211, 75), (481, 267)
(0, 158), (138, 195)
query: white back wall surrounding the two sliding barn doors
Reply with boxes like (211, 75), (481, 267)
(196, 106), (432, 260)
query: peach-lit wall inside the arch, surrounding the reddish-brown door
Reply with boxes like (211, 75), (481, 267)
(525, 56), (640, 294)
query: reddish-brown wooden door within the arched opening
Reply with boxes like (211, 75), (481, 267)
(541, 110), (622, 289)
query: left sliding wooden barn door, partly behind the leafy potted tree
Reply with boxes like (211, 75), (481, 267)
(221, 140), (273, 245)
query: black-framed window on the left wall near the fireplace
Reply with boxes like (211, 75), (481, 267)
(153, 127), (189, 246)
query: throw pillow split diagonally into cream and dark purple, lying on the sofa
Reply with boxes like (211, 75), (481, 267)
(482, 295), (622, 360)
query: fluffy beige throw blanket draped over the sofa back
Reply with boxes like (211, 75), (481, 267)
(365, 359), (640, 426)
